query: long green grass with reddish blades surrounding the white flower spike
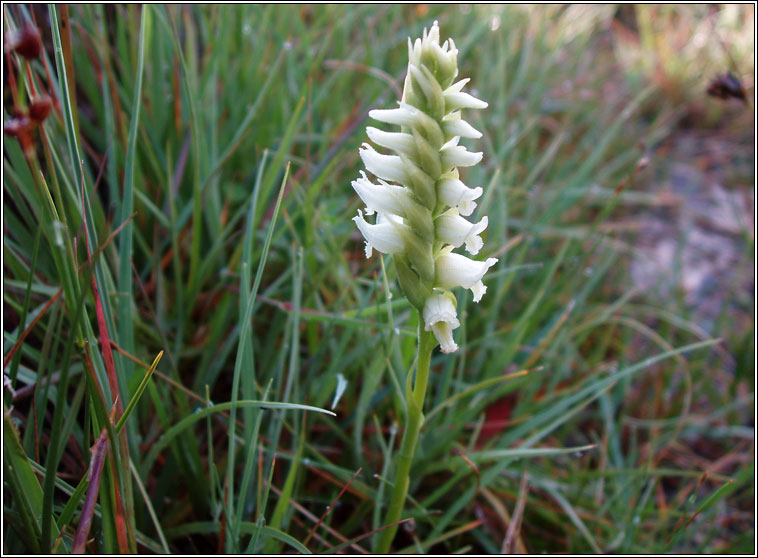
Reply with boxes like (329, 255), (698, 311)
(3, 5), (754, 553)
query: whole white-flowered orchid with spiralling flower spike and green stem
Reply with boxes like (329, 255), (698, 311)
(352, 21), (497, 554)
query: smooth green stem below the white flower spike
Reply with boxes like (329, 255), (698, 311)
(376, 316), (437, 554)
